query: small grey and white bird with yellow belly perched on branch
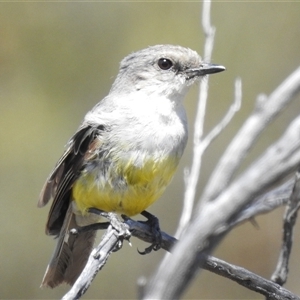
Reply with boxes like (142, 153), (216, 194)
(38, 45), (225, 288)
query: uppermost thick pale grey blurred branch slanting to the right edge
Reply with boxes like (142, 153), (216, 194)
(203, 68), (300, 201)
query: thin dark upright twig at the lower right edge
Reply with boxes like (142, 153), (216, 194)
(271, 170), (300, 285)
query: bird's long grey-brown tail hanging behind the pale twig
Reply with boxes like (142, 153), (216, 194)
(41, 203), (96, 288)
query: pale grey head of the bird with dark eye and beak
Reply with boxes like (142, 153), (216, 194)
(111, 45), (225, 97)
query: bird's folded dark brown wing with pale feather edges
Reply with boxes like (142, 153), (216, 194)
(38, 125), (104, 235)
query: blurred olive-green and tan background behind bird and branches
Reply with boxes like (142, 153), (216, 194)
(0, 1), (300, 299)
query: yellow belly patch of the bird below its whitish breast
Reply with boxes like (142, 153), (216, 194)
(72, 157), (178, 216)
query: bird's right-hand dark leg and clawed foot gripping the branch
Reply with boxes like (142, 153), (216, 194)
(138, 210), (162, 255)
